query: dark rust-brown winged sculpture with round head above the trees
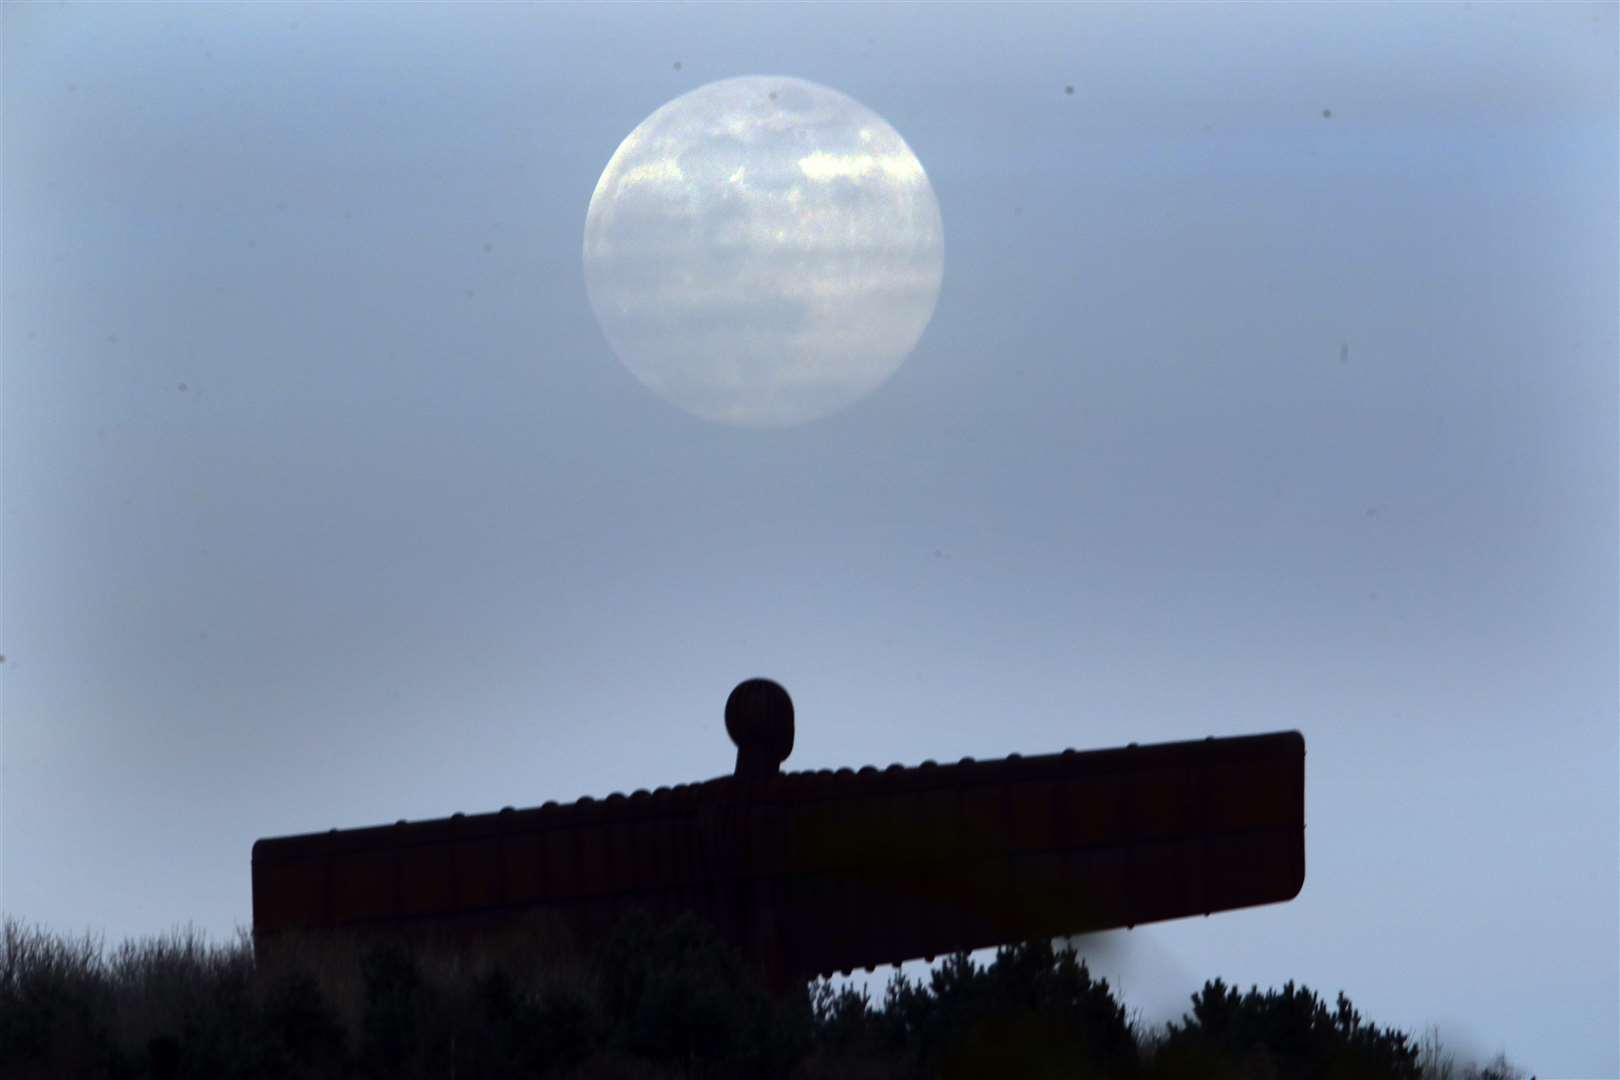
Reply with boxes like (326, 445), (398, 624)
(253, 678), (1304, 986)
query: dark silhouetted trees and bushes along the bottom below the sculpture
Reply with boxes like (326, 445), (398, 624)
(0, 920), (1523, 1080)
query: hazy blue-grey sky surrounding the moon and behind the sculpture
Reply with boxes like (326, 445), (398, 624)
(0, 3), (1620, 1077)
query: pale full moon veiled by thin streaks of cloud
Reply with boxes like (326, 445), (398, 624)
(585, 76), (944, 427)
